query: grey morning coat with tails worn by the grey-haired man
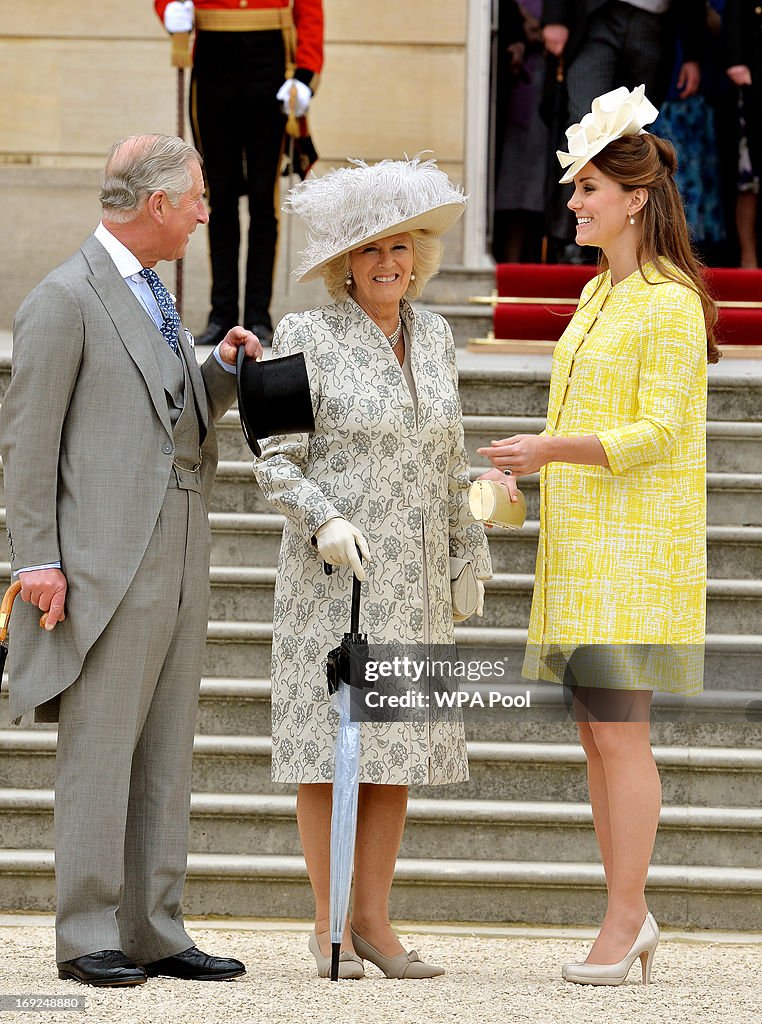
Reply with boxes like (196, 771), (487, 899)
(0, 236), (236, 720)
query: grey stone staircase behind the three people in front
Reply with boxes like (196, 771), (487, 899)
(0, 356), (762, 930)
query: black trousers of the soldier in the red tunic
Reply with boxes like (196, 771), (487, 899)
(191, 31), (286, 327)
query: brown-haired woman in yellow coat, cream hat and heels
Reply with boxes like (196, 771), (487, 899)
(479, 86), (718, 985)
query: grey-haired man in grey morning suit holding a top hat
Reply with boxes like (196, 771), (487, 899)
(0, 135), (261, 985)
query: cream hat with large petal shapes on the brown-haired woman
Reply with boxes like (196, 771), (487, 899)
(556, 85), (659, 184)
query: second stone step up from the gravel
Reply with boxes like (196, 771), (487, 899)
(0, 790), (762, 867)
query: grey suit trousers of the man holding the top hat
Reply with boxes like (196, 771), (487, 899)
(55, 474), (209, 964)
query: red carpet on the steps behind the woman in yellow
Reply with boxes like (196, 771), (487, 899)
(494, 263), (762, 345)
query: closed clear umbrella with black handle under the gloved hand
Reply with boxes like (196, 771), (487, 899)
(325, 563), (368, 981)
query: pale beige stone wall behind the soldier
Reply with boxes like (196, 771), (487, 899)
(0, 0), (467, 332)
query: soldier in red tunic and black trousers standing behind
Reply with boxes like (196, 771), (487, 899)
(155, 0), (323, 345)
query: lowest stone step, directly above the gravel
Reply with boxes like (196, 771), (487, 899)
(0, 850), (762, 931)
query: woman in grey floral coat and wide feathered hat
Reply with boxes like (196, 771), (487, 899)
(254, 160), (491, 978)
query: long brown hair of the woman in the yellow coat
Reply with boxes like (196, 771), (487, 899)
(592, 133), (721, 362)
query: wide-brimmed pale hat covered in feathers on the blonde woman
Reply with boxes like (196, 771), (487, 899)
(284, 157), (467, 281)
